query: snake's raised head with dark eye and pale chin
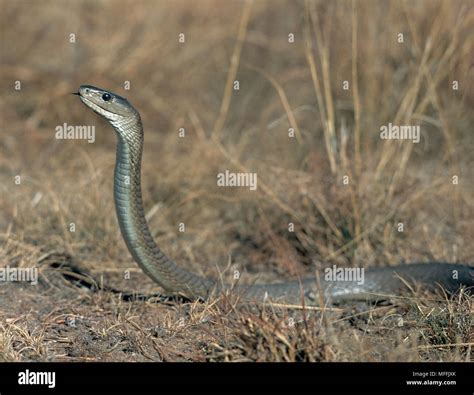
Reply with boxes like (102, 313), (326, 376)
(75, 85), (140, 123)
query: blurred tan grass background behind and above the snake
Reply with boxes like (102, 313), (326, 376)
(0, 0), (474, 286)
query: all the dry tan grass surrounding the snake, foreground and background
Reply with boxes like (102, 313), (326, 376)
(0, 0), (474, 361)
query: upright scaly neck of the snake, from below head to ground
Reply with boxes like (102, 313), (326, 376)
(111, 117), (212, 297)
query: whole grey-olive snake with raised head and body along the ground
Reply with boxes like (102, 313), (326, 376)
(73, 85), (474, 306)
